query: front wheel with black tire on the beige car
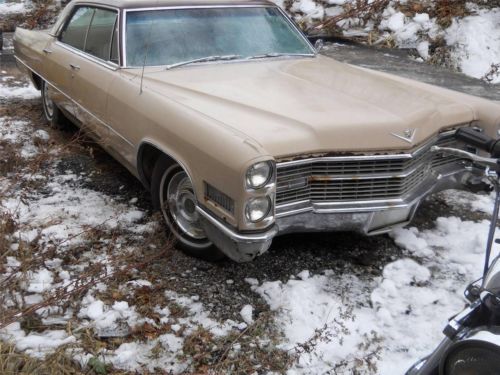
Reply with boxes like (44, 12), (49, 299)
(151, 155), (225, 262)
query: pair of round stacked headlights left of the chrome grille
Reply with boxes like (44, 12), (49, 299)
(245, 161), (274, 223)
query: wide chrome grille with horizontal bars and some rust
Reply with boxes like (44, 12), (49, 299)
(276, 137), (459, 206)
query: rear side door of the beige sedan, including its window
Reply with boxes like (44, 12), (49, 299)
(43, 7), (93, 115)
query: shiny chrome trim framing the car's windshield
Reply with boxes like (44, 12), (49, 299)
(121, 4), (317, 69)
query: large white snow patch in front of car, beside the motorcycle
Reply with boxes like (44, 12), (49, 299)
(251, 210), (498, 374)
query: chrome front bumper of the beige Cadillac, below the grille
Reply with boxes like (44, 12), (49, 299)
(197, 163), (478, 262)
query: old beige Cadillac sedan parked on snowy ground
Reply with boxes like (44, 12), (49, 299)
(11, 0), (500, 262)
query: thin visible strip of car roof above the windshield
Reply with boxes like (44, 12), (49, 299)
(74, 0), (276, 9)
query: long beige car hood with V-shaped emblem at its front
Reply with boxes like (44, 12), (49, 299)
(144, 56), (475, 157)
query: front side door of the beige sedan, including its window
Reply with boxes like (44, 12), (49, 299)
(61, 6), (119, 148)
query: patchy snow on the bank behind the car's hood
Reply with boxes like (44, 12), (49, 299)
(275, 0), (500, 83)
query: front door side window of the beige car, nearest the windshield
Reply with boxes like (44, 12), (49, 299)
(85, 9), (117, 61)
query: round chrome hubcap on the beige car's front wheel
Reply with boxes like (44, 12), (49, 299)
(160, 171), (208, 241)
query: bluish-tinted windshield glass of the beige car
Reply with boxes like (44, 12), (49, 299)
(126, 7), (314, 66)
